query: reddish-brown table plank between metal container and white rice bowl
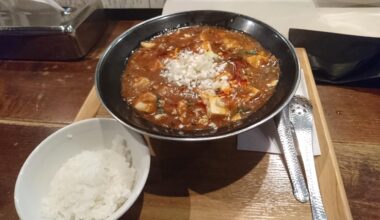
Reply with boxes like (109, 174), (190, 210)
(0, 60), (96, 123)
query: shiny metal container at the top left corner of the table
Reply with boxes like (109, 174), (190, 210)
(0, 1), (106, 60)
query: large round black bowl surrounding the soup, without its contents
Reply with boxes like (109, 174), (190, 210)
(96, 11), (300, 141)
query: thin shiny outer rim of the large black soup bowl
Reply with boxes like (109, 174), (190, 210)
(95, 10), (301, 141)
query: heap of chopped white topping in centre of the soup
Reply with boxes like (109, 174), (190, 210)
(160, 50), (229, 90)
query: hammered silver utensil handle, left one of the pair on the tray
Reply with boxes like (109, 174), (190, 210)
(276, 106), (309, 202)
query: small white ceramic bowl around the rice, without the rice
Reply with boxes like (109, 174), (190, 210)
(14, 119), (150, 220)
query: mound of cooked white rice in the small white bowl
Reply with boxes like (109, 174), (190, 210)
(41, 136), (136, 220)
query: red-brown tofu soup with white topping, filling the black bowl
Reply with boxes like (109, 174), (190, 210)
(121, 26), (280, 130)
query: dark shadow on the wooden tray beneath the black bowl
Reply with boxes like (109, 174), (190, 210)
(144, 136), (266, 219)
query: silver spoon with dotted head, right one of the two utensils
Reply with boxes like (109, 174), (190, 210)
(289, 96), (327, 220)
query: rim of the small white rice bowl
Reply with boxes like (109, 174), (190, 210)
(13, 118), (151, 219)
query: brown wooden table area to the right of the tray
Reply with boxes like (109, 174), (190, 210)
(318, 85), (380, 219)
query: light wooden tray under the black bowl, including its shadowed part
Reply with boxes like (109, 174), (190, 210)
(76, 48), (352, 220)
